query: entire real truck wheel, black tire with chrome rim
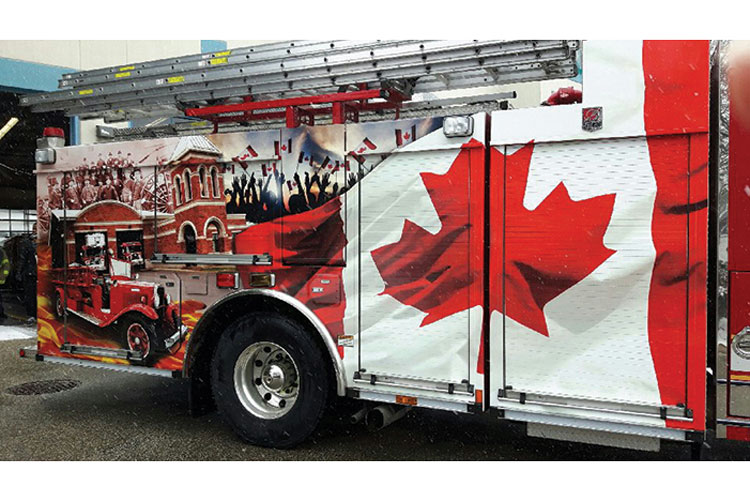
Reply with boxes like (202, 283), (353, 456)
(211, 312), (331, 448)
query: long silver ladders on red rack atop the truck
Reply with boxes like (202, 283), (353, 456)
(20, 40), (580, 124)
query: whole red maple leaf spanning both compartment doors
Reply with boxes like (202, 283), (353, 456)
(371, 143), (615, 335)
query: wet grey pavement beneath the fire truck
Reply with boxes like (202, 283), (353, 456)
(0, 340), (750, 460)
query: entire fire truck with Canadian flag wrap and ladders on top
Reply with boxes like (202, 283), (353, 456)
(17, 41), (750, 452)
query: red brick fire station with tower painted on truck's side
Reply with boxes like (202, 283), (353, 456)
(50, 136), (237, 267)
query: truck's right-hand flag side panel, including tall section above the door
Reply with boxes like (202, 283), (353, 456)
(489, 42), (708, 436)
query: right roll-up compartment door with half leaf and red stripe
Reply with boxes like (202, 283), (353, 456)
(490, 136), (692, 407)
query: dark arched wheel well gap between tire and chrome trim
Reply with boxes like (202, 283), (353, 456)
(183, 294), (339, 414)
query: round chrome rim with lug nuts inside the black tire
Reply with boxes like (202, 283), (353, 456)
(234, 341), (300, 419)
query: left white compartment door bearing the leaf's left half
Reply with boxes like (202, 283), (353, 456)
(358, 117), (484, 391)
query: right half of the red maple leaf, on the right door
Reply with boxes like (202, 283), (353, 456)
(500, 143), (615, 336)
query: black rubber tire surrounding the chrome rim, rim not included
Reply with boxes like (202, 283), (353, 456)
(211, 312), (332, 448)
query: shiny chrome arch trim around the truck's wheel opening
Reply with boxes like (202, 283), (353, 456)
(182, 289), (346, 397)
